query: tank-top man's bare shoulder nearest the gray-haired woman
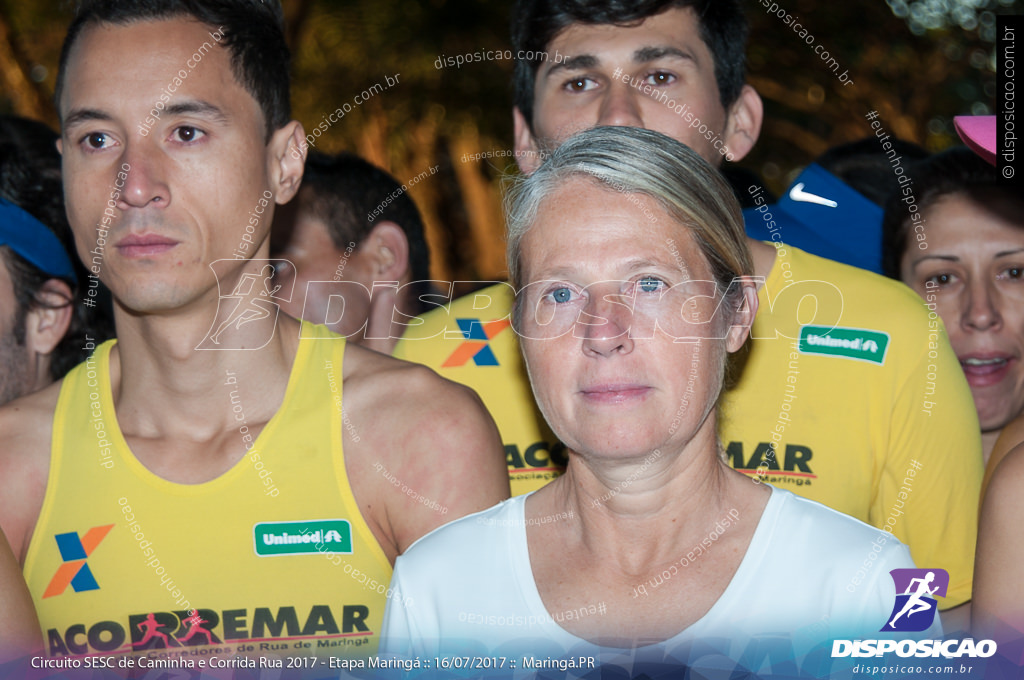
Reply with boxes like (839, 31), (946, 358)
(342, 345), (509, 556)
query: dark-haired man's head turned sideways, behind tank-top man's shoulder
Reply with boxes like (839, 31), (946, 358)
(270, 152), (430, 354)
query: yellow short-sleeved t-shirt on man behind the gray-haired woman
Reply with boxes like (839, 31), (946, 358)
(396, 247), (982, 606)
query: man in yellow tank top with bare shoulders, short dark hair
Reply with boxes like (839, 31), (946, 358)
(0, 0), (508, 659)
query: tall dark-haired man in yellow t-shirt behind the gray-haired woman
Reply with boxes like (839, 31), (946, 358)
(396, 0), (981, 627)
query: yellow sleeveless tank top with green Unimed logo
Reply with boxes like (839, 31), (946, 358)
(25, 324), (396, 670)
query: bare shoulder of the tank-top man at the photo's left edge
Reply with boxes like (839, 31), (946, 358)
(0, 381), (61, 561)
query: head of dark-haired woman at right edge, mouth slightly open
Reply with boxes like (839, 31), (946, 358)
(883, 146), (1024, 461)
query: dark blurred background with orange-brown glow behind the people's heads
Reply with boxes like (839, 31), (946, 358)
(0, 0), (1024, 281)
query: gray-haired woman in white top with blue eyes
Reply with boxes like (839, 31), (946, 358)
(383, 128), (934, 658)
